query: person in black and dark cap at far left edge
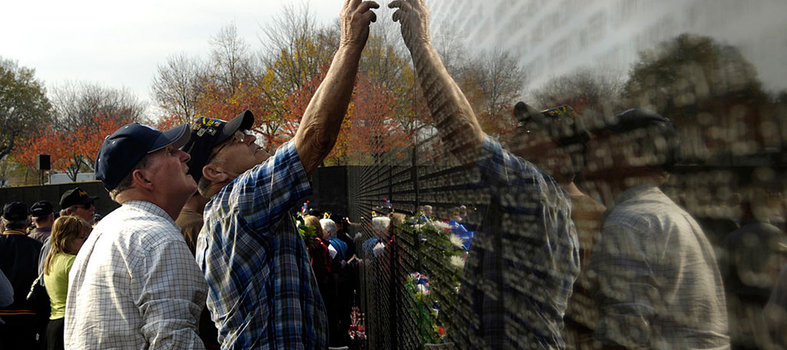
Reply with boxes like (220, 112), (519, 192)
(0, 202), (43, 349)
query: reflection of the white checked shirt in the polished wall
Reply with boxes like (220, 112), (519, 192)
(590, 185), (730, 349)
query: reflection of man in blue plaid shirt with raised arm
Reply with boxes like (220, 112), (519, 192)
(389, 0), (579, 349)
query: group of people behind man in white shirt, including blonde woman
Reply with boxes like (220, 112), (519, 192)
(0, 187), (97, 349)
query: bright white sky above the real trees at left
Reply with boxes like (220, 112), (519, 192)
(0, 0), (343, 115)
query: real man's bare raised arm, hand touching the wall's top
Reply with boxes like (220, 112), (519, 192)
(294, 0), (380, 173)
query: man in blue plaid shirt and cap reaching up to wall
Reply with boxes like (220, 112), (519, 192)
(184, 0), (379, 349)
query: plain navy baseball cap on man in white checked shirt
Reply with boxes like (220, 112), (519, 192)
(95, 123), (191, 191)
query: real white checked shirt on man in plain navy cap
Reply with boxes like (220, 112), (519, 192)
(65, 201), (207, 349)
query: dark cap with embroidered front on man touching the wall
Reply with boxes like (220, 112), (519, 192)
(183, 110), (254, 181)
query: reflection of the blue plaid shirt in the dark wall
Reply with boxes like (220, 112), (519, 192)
(452, 137), (579, 349)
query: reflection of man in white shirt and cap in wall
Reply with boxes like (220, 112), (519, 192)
(585, 109), (730, 349)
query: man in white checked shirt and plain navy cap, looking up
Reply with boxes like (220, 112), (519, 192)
(65, 123), (207, 349)
